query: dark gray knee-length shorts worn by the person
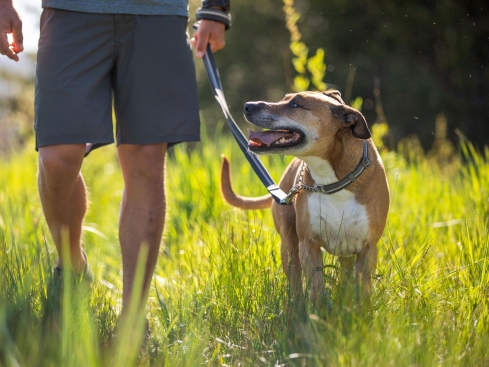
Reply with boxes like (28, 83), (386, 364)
(34, 8), (200, 149)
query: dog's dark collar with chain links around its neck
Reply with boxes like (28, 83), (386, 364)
(281, 140), (370, 205)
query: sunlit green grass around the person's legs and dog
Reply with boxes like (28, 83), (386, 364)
(0, 134), (489, 367)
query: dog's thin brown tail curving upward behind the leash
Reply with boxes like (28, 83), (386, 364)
(221, 155), (273, 209)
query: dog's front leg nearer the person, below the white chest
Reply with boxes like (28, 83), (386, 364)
(299, 239), (324, 306)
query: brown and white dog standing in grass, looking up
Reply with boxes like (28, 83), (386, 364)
(221, 91), (389, 302)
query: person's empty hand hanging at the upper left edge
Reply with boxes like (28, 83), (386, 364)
(0, 1), (24, 61)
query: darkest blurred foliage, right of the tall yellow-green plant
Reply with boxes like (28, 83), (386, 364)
(303, 0), (489, 147)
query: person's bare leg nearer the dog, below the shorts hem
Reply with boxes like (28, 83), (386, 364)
(117, 143), (167, 312)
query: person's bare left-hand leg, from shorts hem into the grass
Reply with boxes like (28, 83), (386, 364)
(38, 144), (87, 273)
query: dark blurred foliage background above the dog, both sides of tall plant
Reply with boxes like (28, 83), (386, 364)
(197, 0), (489, 150)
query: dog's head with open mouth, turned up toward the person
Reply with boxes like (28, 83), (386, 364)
(244, 90), (370, 156)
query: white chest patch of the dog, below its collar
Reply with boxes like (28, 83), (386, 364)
(308, 190), (369, 256)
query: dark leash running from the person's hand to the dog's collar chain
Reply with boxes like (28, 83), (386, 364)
(203, 45), (290, 205)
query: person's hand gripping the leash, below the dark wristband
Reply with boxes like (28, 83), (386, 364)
(191, 19), (226, 57)
